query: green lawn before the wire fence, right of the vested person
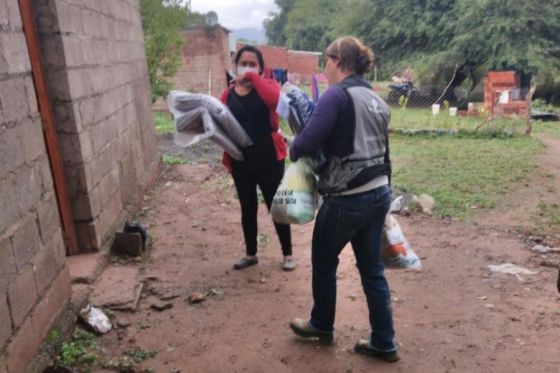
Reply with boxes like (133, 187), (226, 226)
(391, 134), (543, 219)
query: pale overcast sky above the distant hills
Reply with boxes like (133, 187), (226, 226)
(191, 0), (278, 30)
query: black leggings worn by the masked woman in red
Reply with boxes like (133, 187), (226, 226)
(232, 160), (292, 256)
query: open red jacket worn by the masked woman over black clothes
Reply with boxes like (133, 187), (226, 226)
(221, 72), (288, 173)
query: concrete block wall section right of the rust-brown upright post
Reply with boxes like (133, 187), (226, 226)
(34, 0), (159, 250)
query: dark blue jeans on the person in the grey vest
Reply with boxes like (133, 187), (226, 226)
(310, 186), (396, 351)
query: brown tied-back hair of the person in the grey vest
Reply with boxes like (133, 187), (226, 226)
(326, 36), (373, 75)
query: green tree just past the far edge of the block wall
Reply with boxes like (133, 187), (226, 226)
(140, 0), (197, 102)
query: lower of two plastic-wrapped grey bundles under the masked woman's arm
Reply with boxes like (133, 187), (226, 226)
(174, 107), (243, 161)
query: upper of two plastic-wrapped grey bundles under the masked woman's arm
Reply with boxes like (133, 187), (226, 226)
(167, 91), (252, 150)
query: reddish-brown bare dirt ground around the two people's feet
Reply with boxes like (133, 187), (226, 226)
(92, 134), (560, 373)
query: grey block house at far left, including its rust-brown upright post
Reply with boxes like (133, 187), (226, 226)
(0, 0), (159, 373)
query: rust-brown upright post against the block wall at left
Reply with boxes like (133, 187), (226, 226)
(18, 0), (79, 254)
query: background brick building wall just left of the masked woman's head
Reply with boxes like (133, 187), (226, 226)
(173, 25), (231, 97)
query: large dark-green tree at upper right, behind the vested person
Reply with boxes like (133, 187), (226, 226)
(339, 0), (560, 86)
